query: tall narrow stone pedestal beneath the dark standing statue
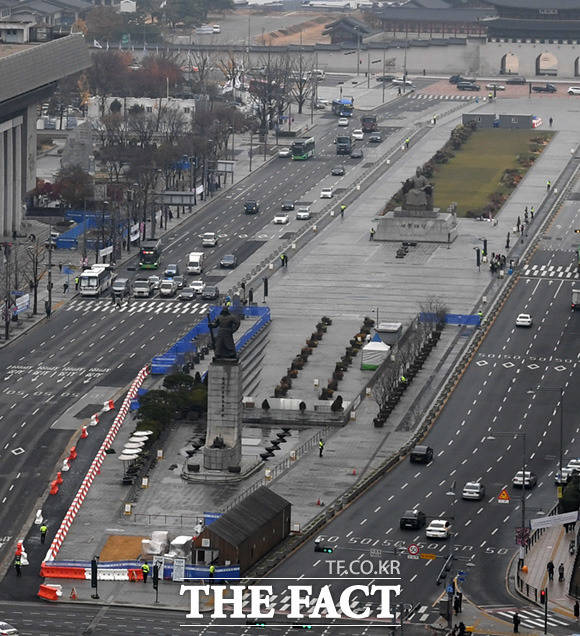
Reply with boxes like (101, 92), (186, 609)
(203, 358), (242, 471)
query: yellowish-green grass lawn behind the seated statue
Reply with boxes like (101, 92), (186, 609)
(430, 128), (546, 216)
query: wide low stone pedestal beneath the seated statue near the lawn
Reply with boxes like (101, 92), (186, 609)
(374, 208), (457, 243)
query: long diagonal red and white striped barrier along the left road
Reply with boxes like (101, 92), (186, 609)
(44, 366), (150, 561)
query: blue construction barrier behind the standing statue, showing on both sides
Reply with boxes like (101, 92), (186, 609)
(151, 305), (270, 375)
